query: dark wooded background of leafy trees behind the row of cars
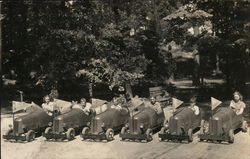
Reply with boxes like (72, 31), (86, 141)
(1, 0), (250, 105)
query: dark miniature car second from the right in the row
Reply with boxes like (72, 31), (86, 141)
(158, 107), (204, 142)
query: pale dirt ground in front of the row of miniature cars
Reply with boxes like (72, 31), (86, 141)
(1, 115), (250, 159)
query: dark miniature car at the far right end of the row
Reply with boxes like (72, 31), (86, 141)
(198, 106), (247, 143)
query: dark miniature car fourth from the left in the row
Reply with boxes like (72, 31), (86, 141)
(120, 101), (165, 142)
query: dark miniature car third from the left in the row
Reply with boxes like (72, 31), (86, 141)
(81, 103), (129, 141)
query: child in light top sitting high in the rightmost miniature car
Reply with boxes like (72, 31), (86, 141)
(229, 92), (246, 115)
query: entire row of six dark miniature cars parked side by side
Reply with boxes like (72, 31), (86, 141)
(3, 99), (247, 143)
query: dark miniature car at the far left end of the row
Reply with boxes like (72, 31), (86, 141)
(3, 105), (53, 142)
